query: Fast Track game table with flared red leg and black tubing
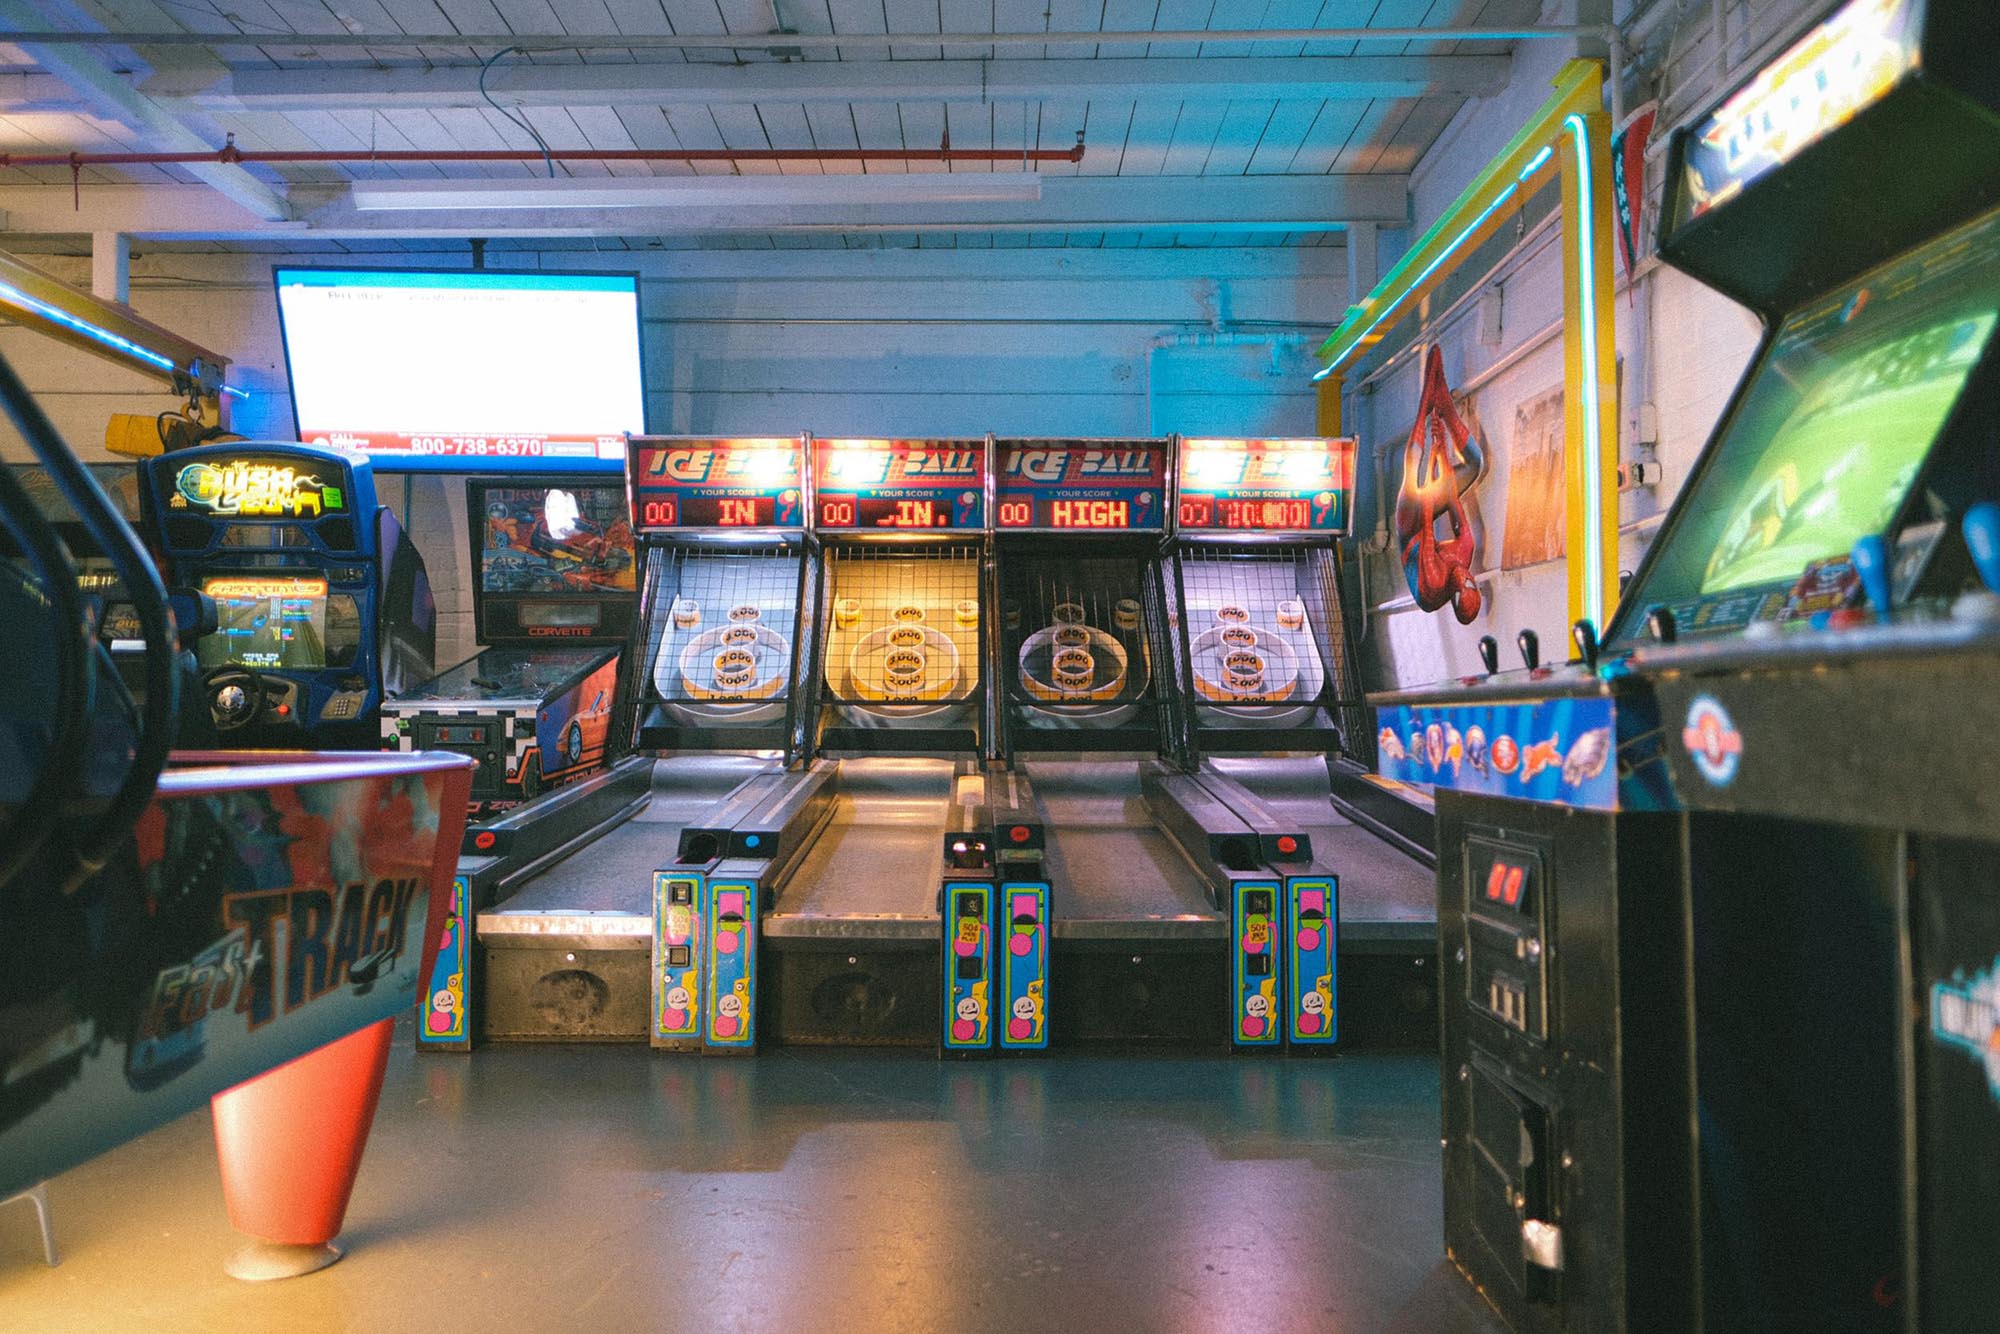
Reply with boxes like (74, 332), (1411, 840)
(0, 362), (468, 1278)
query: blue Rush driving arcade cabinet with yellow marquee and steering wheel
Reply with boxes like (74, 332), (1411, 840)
(142, 442), (436, 750)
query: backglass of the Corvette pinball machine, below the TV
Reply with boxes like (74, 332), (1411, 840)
(472, 486), (638, 594)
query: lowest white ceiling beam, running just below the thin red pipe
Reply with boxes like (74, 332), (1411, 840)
(0, 174), (1410, 248)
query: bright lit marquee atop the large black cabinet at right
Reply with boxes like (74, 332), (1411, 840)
(1672, 0), (1920, 224)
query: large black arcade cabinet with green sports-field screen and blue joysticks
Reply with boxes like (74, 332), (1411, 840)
(1380, 0), (2000, 1330)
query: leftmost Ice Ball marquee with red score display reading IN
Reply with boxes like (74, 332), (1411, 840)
(626, 436), (804, 532)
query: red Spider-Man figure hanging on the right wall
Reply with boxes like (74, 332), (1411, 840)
(1396, 344), (1488, 626)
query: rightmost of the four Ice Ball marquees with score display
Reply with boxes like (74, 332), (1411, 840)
(1178, 438), (1354, 532)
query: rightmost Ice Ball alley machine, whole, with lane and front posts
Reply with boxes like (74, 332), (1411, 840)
(1168, 438), (1436, 1046)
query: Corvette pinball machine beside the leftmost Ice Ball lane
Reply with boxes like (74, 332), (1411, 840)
(382, 476), (638, 816)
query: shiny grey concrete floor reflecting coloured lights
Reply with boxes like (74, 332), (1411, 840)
(0, 1040), (1498, 1334)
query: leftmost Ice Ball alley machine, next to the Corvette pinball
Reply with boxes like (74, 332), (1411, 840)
(464, 436), (816, 1054)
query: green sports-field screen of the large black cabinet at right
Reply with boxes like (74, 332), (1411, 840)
(1628, 205), (2000, 648)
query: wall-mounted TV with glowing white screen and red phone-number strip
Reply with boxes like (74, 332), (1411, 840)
(276, 268), (646, 472)
